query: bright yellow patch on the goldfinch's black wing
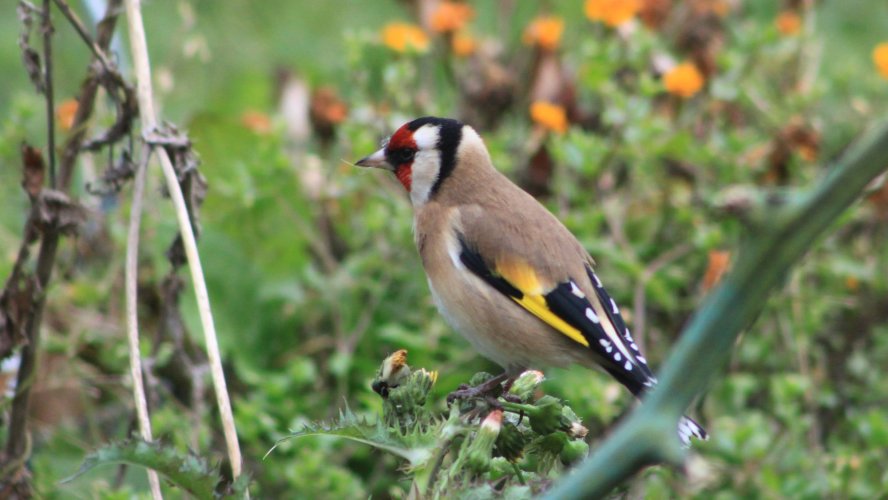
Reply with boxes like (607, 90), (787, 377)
(496, 258), (589, 347)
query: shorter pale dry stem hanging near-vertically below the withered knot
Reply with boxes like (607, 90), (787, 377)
(124, 148), (163, 500)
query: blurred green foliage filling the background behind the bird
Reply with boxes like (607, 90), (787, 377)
(0, 0), (888, 498)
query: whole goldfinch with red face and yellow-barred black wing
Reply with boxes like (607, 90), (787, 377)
(356, 117), (706, 445)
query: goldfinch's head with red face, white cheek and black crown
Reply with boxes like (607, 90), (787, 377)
(356, 116), (486, 207)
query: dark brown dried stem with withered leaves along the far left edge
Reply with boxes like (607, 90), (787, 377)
(0, 0), (126, 492)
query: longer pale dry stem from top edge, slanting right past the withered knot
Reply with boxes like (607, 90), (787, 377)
(126, 0), (241, 479)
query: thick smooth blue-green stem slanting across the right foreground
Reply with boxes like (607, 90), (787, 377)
(545, 123), (888, 499)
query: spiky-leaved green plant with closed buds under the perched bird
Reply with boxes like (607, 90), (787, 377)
(276, 350), (589, 498)
